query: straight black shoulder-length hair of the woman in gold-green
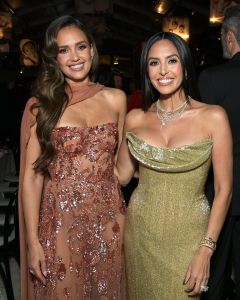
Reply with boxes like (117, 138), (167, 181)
(140, 32), (198, 111)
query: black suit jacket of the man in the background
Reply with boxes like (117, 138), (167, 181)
(198, 52), (240, 216)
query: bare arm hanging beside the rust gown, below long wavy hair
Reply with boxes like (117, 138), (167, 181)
(22, 125), (46, 283)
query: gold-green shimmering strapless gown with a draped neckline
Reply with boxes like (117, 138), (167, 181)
(124, 133), (212, 300)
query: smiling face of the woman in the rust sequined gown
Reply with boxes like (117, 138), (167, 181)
(56, 26), (93, 82)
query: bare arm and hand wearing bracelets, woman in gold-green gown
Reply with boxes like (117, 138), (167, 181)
(184, 107), (232, 296)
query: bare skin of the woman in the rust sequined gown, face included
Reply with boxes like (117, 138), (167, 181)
(23, 26), (126, 284)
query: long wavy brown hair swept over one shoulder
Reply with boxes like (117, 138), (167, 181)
(32, 16), (98, 174)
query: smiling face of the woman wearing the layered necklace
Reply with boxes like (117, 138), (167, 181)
(147, 39), (183, 96)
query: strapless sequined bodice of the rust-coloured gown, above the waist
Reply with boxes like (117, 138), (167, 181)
(48, 123), (118, 180)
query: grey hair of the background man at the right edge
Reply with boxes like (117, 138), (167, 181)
(222, 4), (240, 44)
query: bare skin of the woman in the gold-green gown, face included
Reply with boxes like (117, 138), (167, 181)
(115, 39), (232, 296)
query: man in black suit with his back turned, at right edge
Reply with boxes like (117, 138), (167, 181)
(198, 5), (240, 300)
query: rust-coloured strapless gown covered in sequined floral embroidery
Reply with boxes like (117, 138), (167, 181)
(34, 123), (125, 300)
